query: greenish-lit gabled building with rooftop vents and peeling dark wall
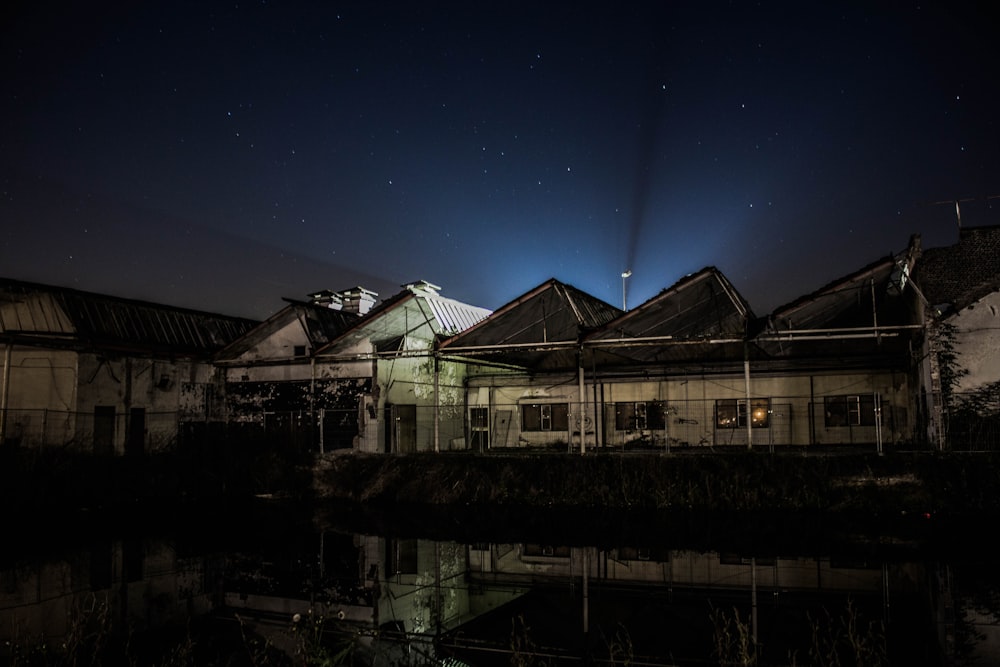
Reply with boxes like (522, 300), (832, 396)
(216, 281), (489, 452)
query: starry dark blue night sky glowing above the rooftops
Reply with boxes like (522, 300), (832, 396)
(0, 0), (1000, 318)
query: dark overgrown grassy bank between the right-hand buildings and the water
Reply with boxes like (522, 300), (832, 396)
(316, 451), (1000, 516)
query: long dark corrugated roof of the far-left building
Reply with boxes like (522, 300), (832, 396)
(0, 278), (257, 356)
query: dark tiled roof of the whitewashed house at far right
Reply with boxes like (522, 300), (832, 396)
(913, 226), (1000, 310)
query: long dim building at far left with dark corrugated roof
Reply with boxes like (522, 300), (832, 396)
(0, 279), (255, 454)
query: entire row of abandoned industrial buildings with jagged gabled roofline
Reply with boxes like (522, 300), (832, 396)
(0, 228), (1000, 454)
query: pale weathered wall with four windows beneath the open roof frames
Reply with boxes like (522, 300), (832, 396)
(468, 372), (913, 447)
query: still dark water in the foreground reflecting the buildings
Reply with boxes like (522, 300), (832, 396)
(0, 503), (1000, 665)
